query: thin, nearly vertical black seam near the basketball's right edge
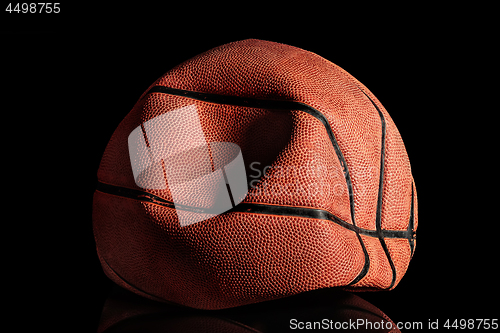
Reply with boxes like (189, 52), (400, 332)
(361, 90), (396, 289)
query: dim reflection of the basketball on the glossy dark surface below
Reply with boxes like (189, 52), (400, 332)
(98, 286), (397, 333)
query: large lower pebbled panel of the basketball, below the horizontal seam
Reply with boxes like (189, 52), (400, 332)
(94, 192), (364, 309)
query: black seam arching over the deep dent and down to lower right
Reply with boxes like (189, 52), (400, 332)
(143, 86), (370, 285)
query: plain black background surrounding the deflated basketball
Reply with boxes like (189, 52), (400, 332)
(1, 5), (499, 332)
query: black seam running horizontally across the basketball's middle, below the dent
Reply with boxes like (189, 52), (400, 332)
(96, 182), (414, 239)
